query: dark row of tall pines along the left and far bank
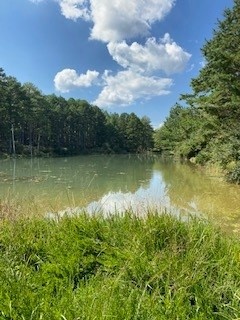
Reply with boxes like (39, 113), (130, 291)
(0, 68), (153, 156)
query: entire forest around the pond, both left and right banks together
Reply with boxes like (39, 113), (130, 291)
(0, 0), (240, 183)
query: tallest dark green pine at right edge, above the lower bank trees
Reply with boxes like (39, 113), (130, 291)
(183, 0), (240, 122)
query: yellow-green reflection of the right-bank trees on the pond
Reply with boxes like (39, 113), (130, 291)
(154, 161), (240, 232)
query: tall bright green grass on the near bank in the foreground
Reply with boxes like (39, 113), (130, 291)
(0, 214), (240, 320)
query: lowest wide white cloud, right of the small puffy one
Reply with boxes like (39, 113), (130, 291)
(93, 70), (172, 107)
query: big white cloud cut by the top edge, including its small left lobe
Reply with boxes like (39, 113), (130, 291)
(51, 0), (175, 42)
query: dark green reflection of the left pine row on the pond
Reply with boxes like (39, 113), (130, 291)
(0, 155), (154, 209)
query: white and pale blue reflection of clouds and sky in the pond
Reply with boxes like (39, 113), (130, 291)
(47, 170), (200, 218)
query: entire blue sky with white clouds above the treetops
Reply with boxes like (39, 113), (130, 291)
(0, 0), (233, 128)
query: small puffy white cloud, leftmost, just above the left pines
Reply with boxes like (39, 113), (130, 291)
(54, 69), (99, 92)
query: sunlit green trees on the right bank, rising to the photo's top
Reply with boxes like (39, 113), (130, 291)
(155, 0), (240, 183)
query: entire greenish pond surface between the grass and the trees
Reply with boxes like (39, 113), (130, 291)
(0, 155), (240, 232)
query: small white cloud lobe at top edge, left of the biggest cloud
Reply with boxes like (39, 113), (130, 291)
(58, 0), (91, 21)
